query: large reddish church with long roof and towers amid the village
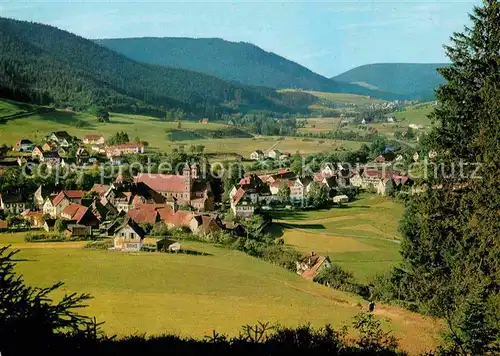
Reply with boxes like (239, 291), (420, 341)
(134, 164), (214, 211)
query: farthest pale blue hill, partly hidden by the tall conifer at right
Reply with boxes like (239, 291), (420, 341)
(332, 63), (447, 101)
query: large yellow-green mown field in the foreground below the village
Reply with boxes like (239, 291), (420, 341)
(0, 233), (441, 354)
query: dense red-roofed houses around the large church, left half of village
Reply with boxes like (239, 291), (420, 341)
(0, 164), (250, 251)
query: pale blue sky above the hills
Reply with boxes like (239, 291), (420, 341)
(0, 0), (480, 77)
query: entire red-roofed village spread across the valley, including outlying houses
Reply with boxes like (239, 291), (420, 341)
(0, 131), (413, 280)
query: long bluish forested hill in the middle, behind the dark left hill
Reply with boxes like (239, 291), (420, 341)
(95, 37), (406, 100)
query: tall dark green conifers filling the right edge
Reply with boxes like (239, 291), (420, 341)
(378, 0), (500, 355)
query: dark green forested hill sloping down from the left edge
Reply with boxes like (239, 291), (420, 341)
(0, 18), (288, 111)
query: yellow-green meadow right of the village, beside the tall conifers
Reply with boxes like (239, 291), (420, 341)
(275, 194), (403, 283)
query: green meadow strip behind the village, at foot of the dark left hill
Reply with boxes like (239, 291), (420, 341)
(0, 111), (360, 157)
